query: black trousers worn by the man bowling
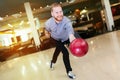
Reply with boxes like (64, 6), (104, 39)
(52, 40), (72, 73)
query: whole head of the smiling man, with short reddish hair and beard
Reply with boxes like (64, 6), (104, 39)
(51, 3), (63, 22)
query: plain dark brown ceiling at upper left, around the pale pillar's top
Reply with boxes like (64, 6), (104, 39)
(0, 0), (66, 16)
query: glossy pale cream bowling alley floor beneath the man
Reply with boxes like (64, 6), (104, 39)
(0, 30), (120, 80)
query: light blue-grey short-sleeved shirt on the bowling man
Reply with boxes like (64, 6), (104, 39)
(45, 16), (74, 42)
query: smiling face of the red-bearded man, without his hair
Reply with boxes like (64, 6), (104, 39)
(51, 6), (63, 22)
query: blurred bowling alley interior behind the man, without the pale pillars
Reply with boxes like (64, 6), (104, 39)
(0, 0), (120, 62)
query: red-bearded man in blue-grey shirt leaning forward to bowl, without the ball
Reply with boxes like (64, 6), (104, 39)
(45, 3), (75, 79)
